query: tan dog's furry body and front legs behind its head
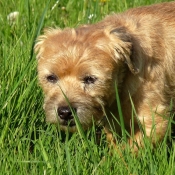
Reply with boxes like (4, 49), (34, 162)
(97, 2), (175, 149)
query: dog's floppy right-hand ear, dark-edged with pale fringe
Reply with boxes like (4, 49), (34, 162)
(110, 27), (139, 74)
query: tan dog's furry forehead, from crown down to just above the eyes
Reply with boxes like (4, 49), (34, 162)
(38, 27), (114, 76)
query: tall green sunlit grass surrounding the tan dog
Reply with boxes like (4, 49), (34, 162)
(0, 0), (175, 175)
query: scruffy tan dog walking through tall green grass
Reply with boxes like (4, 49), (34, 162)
(35, 2), (175, 150)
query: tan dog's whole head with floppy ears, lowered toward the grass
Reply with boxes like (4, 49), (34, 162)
(35, 26), (135, 131)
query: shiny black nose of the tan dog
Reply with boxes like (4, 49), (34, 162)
(57, 106), (76, 121)
